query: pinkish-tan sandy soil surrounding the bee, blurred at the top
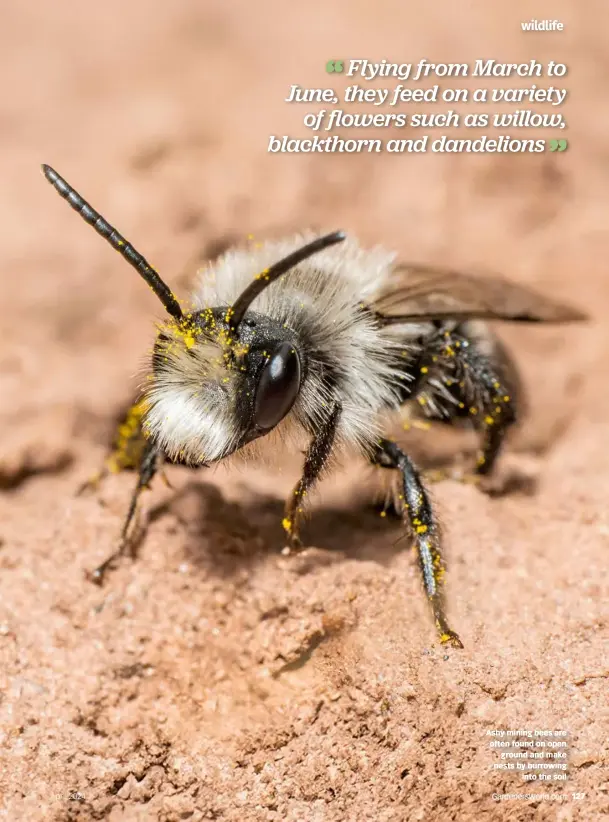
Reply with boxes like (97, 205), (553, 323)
(0, 0), (609, 822)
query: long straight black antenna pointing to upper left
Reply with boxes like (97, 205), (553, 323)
(42, 164), (182, 320)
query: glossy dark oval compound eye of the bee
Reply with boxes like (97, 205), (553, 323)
(254, 342), (301, 431)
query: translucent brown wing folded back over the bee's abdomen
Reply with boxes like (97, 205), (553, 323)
(370, 264), (588, 325)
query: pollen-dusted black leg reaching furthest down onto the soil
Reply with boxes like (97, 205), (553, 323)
(373, 439), (463, 648)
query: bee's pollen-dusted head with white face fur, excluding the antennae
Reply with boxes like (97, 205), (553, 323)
(145, 306), (306, 465)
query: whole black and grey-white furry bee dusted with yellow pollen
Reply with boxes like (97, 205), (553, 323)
(43, 165), (586, 647)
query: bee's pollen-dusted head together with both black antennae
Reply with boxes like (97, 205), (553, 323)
(42, 165), (345, 465)
